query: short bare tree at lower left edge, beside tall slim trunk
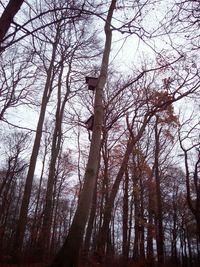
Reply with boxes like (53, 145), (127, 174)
(0, 132), (29, 254)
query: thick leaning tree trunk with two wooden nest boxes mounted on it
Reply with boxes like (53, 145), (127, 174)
(51, 0), (116, 267)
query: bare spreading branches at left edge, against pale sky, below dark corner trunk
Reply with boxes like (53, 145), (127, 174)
(0, 47), (37, 122)
